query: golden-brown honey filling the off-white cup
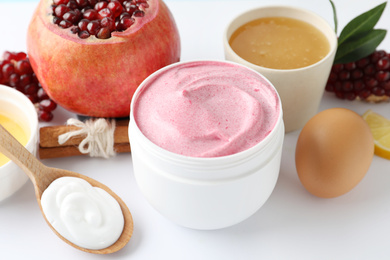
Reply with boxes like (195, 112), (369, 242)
(229, 17), (330, 69)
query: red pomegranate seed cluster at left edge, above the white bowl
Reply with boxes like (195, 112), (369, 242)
(0, 51), (57, 122)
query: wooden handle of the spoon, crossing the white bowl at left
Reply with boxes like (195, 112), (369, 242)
(0, 124), (45, 194)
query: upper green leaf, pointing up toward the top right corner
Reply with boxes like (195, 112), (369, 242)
(338, 2), (386, 45)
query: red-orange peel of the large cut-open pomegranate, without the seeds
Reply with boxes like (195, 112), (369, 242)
(27, 0), (180, 117)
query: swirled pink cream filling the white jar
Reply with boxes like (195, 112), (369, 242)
(133, 61), (281, 157)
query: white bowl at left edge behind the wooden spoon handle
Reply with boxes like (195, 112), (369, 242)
(0, 85), (38, 201)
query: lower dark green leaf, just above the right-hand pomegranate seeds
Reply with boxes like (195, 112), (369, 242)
(334, 29), (386, 64)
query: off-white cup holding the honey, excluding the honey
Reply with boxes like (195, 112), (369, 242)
(223, 6), (337, 132)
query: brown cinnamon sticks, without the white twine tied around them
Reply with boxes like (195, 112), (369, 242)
(39, 120), (131, 159)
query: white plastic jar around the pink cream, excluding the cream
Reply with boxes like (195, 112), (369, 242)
(129, 62), (284, 230)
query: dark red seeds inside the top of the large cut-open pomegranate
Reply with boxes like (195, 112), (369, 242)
(52, 0), (149, 39)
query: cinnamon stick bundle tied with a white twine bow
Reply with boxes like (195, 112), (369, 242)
(39, 118), (130, 159)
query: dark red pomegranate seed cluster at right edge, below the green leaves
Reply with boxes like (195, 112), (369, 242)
(325, 50), (390, 102)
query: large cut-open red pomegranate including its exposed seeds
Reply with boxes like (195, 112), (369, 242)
(27, 0), (180, 117)
